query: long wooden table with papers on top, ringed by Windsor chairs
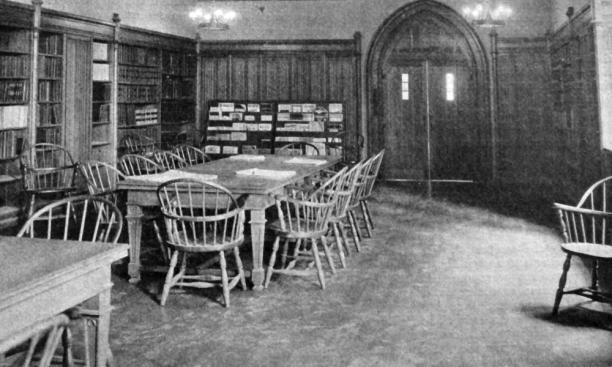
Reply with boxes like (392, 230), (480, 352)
(118, 155), (341, 290)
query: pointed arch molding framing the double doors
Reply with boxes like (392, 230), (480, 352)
(366, 0), (491, 157)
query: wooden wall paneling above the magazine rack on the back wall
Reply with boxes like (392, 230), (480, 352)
(199, 36), (360, 158)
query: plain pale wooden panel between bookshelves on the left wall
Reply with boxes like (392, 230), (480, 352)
(64, 36), (92, 165)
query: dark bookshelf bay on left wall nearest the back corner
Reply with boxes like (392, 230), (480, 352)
(161, 50), (197, 145)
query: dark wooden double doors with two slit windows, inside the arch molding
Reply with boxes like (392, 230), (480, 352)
(376, 14), (488, 182)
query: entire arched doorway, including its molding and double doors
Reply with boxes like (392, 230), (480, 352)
(366, 0), (491, 188)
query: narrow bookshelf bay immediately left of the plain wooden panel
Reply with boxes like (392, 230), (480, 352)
(36, 32), (64, 145)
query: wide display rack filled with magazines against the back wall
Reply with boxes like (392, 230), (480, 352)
(204, 101), (346, 156)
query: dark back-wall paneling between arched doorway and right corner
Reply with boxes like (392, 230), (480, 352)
(497, 39), (557, 190)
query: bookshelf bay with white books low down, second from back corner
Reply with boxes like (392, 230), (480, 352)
(117, 44), (161, 147)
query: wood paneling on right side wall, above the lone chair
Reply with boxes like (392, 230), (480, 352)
(550, 11), (605, 195)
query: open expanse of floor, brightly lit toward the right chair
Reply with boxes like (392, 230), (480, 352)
(111, 186), (612, 367)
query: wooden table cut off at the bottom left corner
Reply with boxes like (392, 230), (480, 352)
(0, 236), (128, 366)
